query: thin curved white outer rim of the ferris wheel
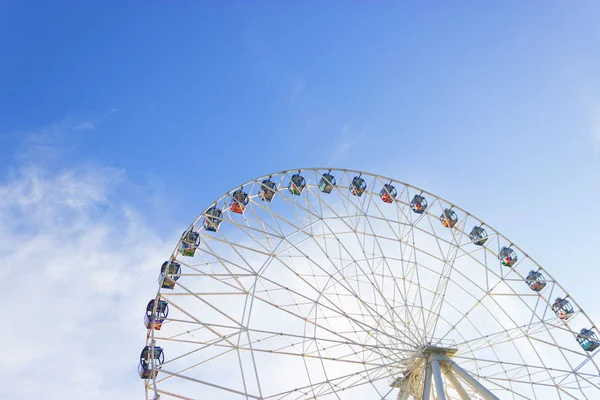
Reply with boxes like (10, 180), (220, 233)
(146, 167), (598, 400)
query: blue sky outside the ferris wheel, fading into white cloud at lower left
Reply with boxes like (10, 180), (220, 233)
(0, 0), (600, 399)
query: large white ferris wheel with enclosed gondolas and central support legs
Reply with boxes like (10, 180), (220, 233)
(138, 168), (600, 400)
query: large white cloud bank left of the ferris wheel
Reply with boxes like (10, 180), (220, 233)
(0, 117), (172, 400)
